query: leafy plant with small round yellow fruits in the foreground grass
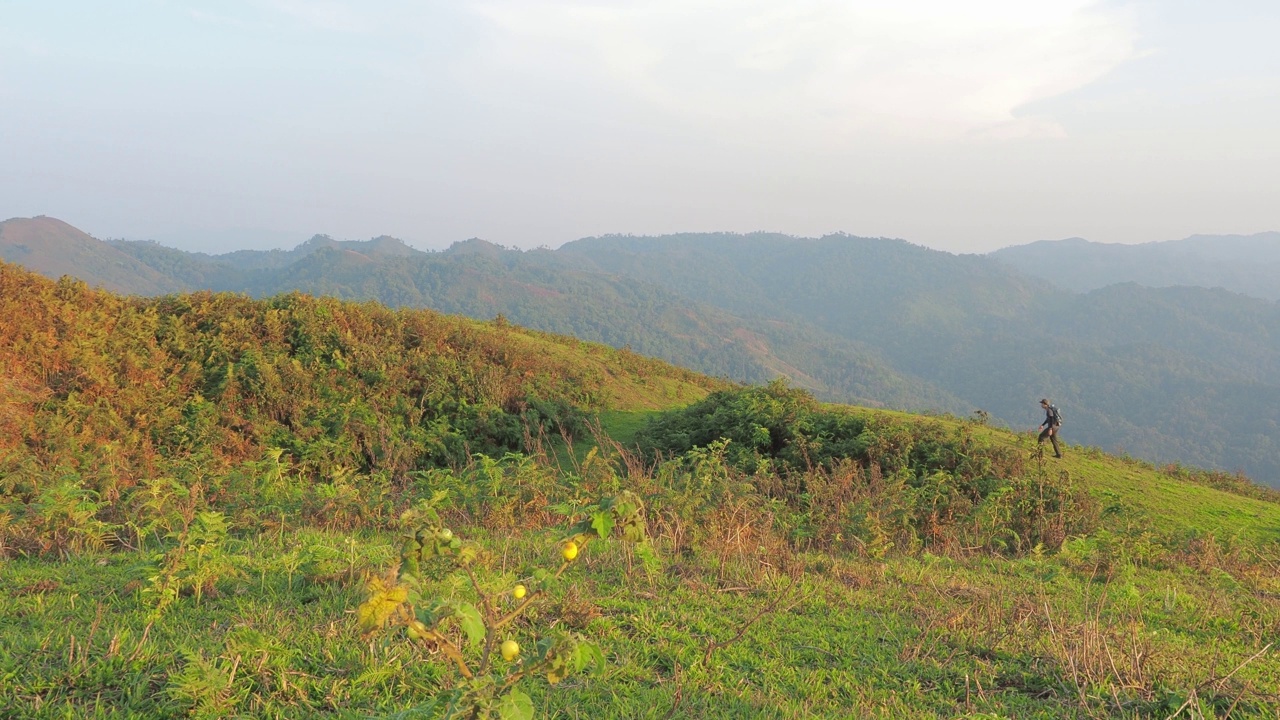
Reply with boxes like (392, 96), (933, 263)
(356, 492), (655, 720)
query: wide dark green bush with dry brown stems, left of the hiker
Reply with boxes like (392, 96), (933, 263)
(637, 380), (1097, 556)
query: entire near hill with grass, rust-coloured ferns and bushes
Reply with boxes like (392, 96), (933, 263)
(0, 264), (1280, 719)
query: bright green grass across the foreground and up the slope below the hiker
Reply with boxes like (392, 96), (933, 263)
(0, 411), (1280, 719)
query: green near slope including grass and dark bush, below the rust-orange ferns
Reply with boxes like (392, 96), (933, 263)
(0, 371), (1280, 720)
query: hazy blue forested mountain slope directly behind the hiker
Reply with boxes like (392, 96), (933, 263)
(561, 233), (1280, 487)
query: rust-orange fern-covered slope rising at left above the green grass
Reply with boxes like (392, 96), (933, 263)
(0, 264), (723, 492)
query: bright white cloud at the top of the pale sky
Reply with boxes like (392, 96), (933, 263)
(471, 0), (1137, 142)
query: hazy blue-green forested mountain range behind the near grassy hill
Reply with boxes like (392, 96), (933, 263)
(0, 218), (1280, 486)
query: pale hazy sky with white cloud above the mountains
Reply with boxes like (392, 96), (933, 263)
(0, 0), (1280, 252)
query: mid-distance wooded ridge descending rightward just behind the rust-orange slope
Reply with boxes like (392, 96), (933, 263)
(112, 230), (969, 413)
